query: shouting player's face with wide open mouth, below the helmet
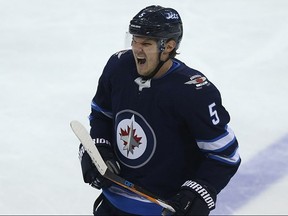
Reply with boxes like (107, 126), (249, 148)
(132, 36), (159, 76)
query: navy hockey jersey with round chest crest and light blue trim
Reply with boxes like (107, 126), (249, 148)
(83, 50), (241, 214)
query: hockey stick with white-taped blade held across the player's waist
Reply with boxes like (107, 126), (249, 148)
(70, 121), (175, 212)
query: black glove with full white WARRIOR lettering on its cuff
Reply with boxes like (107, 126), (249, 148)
(162, 180), (217, 215)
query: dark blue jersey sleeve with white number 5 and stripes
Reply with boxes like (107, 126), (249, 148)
(178, 83), (241, 193)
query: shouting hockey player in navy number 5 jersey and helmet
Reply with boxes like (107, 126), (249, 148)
(79, 6), (241, 215)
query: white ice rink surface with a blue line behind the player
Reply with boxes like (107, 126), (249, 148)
(0, 0), (288, 215)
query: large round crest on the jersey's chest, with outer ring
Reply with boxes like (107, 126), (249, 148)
(115, 110), (156, 168)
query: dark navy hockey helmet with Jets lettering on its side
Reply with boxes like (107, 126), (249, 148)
(129, 5), (183, 49)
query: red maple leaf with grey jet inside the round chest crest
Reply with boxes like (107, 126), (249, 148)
(120, 115), (142, 157)
